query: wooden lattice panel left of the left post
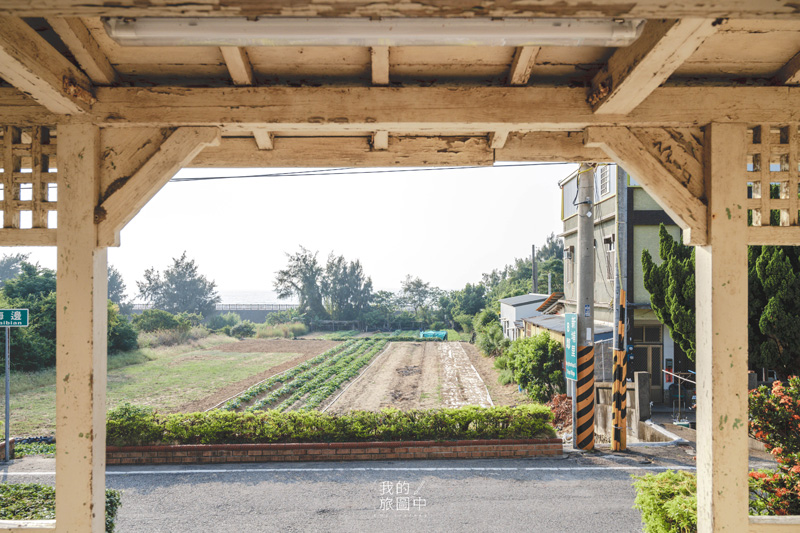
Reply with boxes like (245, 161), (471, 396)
(0, 126), (58, 234)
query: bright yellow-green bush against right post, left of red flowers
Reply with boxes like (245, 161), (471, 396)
(633, 470), (697, 533)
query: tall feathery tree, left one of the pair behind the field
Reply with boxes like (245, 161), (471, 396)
(274, 246), (328, 319)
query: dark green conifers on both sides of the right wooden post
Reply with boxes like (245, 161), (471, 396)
(642, 225), (800, 377)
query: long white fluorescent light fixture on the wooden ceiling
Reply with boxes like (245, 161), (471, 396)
(104, 17), (645, 47)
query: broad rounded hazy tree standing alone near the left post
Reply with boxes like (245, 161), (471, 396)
(136, 252), (220, 316)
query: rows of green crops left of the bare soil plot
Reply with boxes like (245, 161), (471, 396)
(222, 339), (387, 411)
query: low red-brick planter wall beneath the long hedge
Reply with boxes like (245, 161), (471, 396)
(106, 439), (562, 465)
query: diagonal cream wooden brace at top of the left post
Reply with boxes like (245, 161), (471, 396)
(95, 128), (220, 246)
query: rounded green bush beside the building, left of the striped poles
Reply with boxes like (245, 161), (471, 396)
(507, 332), (564, 402)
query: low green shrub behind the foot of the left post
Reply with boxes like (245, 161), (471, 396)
(0, 483), (122, 533)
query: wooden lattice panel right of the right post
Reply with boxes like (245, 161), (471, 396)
(745, 124), (800, 230)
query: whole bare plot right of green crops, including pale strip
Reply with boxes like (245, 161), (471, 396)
(328, 342), (492, 413)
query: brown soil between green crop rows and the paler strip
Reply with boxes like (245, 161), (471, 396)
(328, 342), (442, 414)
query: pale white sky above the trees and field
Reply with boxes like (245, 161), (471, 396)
(9, 164), (577, 303)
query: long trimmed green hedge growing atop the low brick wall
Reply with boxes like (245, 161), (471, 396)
(106, 404), (555, 446)
